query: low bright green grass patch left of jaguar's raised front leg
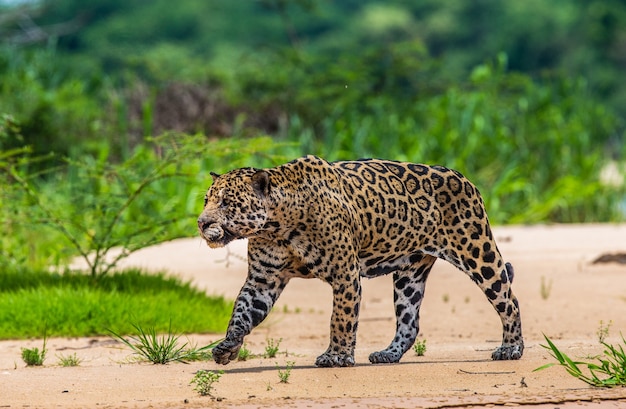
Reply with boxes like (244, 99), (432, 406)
(0, 270), (232, 339)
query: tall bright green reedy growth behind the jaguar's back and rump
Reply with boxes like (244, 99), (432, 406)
(274, 53), (626, 223)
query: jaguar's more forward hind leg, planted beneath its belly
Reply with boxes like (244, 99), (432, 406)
(369, 255), (437, 364)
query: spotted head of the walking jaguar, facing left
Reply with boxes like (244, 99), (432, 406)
(198, 168), (270, 248)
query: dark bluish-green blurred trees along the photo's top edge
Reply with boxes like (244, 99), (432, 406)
(22, 0), (626, 111)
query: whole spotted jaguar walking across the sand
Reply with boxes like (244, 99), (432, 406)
(198, 156), (524, 367)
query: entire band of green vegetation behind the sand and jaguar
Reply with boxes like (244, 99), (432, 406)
(0, 0), (626, 275)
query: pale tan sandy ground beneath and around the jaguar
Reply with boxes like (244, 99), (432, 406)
(0, 225), (626, 409)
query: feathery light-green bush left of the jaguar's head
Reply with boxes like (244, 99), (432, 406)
(0, 135), (288, 270)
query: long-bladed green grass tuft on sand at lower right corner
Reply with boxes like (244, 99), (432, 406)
(535, 335), (626, 388)
